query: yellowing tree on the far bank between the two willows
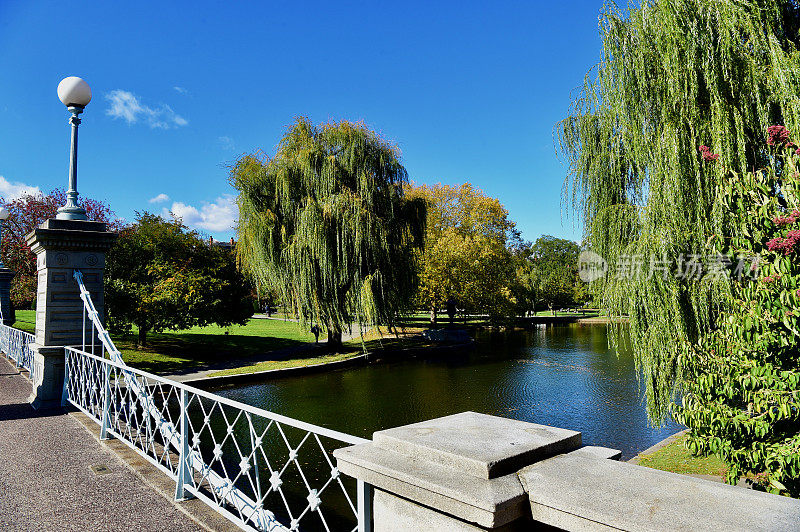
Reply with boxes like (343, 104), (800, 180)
(411, 183), (519, 321)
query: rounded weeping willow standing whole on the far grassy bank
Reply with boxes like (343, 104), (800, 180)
(230, 118), (426, 347)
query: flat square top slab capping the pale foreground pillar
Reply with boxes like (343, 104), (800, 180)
(372, 412), (581, 479)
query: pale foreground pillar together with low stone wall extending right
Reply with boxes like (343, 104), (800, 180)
(334, 412), (800, 532)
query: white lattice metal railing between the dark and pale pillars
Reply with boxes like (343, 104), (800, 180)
(64, 271), (371, 531)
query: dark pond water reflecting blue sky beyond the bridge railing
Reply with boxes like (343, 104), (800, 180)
(217, 325), (680, 459)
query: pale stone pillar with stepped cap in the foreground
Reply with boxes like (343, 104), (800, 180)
(334, 412), (581, 532)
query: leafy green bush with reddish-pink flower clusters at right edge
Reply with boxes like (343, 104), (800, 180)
(676, 128), (800, 497)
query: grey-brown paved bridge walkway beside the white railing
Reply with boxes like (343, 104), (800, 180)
(0, 355), (209, 532)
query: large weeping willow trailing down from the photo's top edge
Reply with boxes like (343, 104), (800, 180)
(556, 0), (800, 423)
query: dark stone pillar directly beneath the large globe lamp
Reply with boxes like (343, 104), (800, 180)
(27, 219), (116, 409)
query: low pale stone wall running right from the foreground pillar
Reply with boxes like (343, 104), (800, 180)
(519, 453), (800, 532)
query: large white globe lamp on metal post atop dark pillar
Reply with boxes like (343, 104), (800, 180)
(56, 76), (92, 220)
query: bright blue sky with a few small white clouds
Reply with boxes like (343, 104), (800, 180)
(0, 0), (602, 240)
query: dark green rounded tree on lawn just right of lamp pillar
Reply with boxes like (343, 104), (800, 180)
(105, 213), (253, 345)
